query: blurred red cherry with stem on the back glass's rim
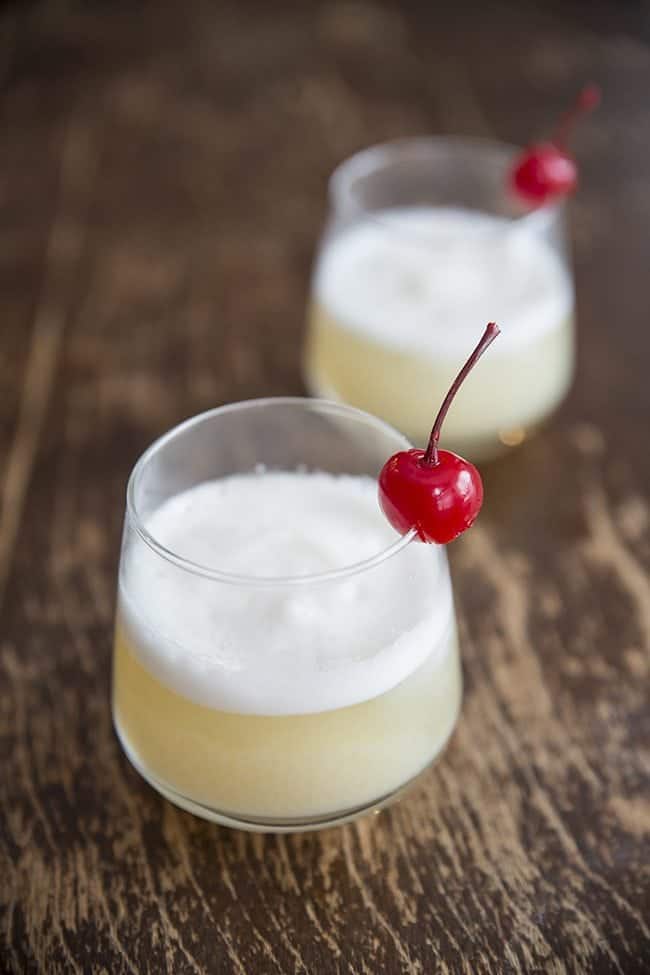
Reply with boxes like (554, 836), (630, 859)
(510, 85), (600, 207)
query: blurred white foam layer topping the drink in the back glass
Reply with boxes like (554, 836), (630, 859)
(314, 207), (573, 359)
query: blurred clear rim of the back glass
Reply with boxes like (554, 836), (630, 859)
(327, 135), (565, 229)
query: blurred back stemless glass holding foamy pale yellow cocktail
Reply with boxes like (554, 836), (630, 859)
(304, 137), (574, 460)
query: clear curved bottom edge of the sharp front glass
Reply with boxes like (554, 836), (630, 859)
(113, 717), (456, 833)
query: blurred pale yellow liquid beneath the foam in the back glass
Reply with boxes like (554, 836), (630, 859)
(305, 300), (574, 460)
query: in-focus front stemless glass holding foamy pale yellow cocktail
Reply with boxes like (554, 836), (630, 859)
(113, 399), (461, 832)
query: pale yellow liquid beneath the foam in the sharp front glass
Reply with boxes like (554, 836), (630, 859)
(113, 611), (461, 820)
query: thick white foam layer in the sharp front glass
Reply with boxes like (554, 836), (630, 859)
(119, 472), (452, 715)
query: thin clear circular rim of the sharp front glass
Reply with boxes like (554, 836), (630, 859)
(126, 396), (417, 588)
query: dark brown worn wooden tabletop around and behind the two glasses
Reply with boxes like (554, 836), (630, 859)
(0, 0), (650, 975)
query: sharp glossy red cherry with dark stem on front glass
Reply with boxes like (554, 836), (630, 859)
(379, 322), (499, 545)
